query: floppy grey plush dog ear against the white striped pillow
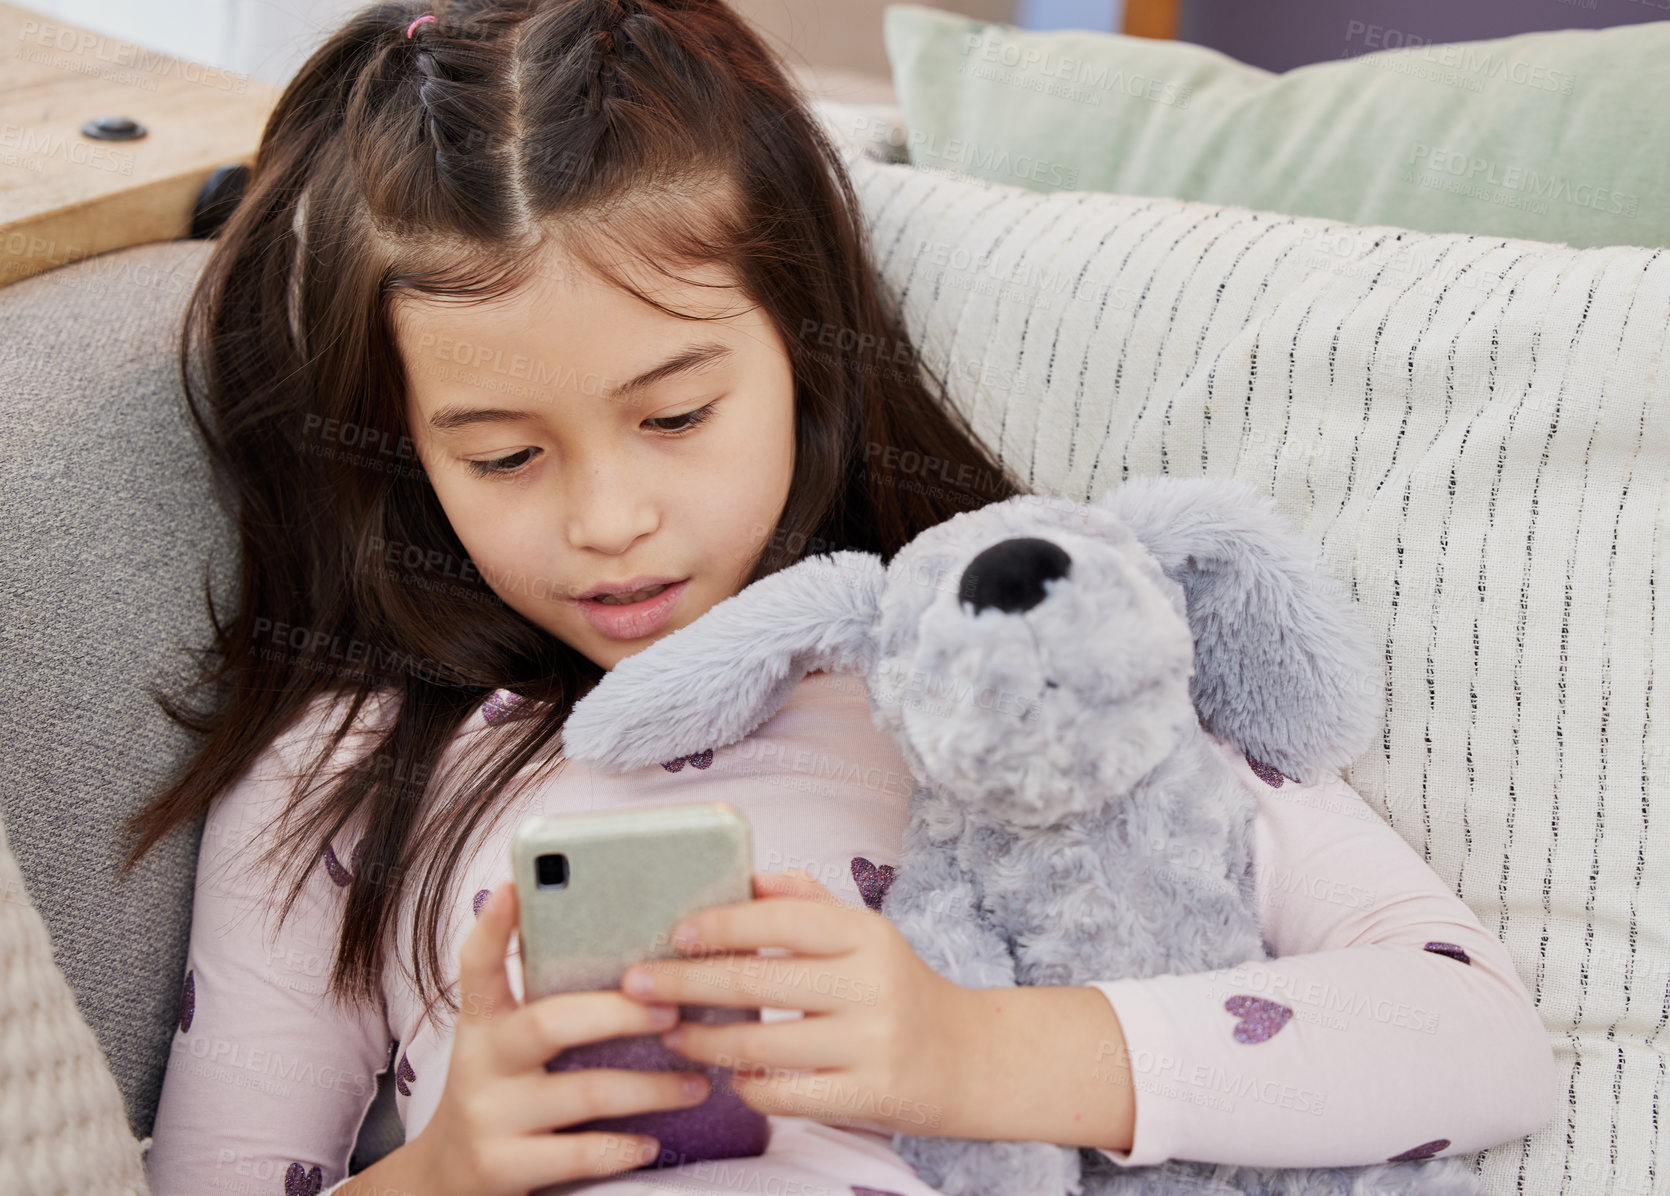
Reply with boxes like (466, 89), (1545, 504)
(1097, 478), (1384, 782)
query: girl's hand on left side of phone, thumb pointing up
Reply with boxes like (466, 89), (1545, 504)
(411, 880), (708, 1196)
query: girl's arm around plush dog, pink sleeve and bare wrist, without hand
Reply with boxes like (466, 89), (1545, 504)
(959, 734), (1563, 1168)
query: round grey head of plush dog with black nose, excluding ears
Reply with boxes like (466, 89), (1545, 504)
(865, 494), (1196, 825)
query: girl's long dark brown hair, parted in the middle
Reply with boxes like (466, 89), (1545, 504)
(124, 0), (1024, 1028)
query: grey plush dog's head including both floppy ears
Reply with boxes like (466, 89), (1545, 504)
(563, 478), (1381, 825)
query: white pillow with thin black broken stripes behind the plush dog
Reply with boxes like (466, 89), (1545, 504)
(848, 139), (1670, 1196)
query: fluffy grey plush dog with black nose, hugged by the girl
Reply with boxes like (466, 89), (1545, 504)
(563, 478), (1485, 1196)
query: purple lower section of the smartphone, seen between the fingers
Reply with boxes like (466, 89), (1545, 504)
(544, 1006), (772, 1171)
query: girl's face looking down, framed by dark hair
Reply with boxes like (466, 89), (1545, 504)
(394, 242), (795, 668)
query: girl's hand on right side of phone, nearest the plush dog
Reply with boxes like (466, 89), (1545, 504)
(621, 870), (975, 1138)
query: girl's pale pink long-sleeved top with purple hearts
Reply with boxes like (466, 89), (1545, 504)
(147, 673), (1561, 1196)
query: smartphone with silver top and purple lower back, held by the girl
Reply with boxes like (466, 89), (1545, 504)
(511, 802), (772, 1171)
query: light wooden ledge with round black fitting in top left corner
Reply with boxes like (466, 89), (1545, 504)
(0, 3), (279, 286)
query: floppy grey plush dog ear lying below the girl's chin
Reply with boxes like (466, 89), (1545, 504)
(563, 551), (885, 772)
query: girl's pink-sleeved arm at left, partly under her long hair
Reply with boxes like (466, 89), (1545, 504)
(145, 694), (392, 1193)
